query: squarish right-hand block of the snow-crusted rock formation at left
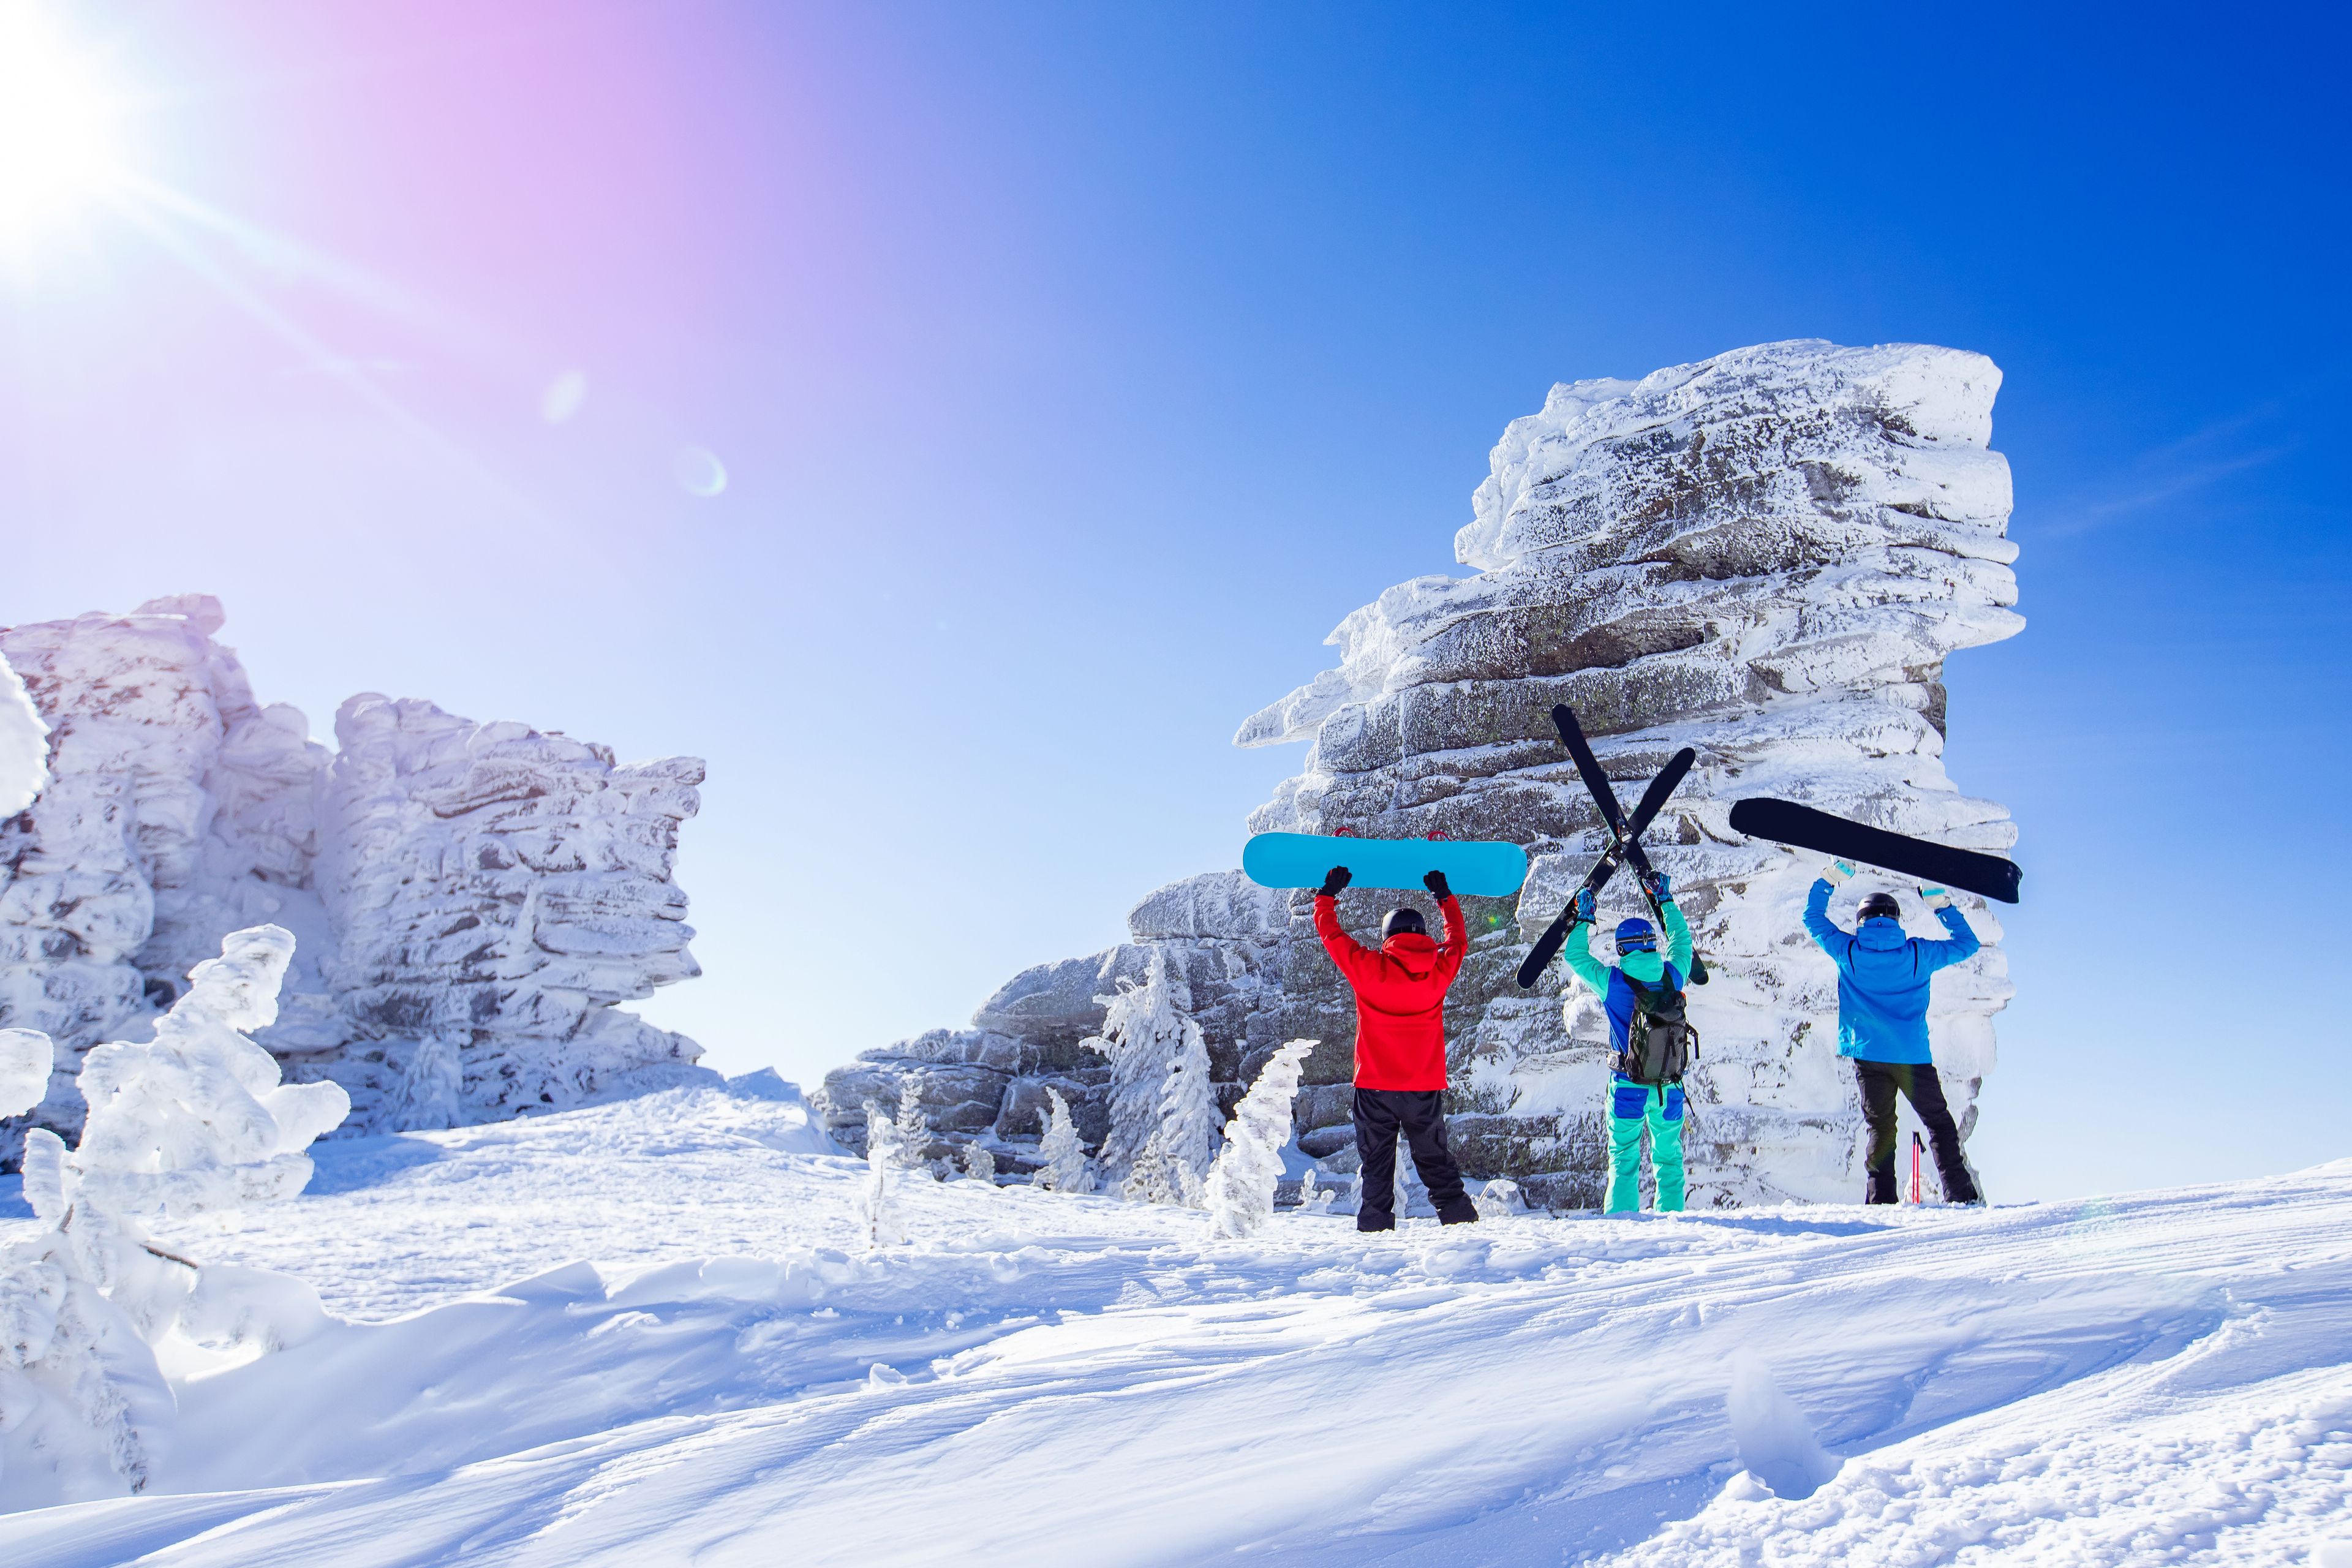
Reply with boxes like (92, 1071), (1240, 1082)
(317, 693), (703, 1126)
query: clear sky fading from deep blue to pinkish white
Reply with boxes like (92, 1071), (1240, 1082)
(0, 0), (2352, 1197)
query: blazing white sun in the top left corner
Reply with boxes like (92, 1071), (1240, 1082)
(0, 0), (120, 247)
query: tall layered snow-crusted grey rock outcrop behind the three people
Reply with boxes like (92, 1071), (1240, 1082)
(818, 341), (2022, 1206)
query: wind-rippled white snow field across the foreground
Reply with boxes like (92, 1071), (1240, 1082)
(0, 1091), (2352, 1568)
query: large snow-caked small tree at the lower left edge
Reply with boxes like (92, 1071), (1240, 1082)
(0, 926), (350, 1502)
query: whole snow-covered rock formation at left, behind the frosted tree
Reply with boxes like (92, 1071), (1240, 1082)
(0, 595), (703, 1161)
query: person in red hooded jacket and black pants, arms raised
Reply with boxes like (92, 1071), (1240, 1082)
(1315, 865), (1477, 1229)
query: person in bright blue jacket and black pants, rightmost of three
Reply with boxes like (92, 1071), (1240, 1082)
(1804, 861), (1983, 1204)
